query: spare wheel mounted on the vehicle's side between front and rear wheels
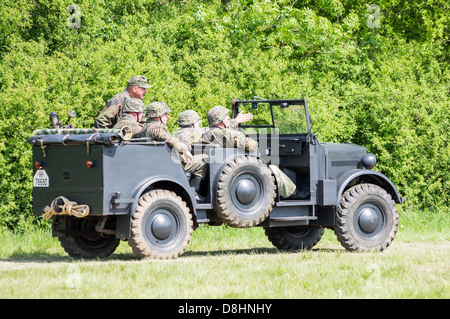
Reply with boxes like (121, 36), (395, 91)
(214, 156), (276, 228)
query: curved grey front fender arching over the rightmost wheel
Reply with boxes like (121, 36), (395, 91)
(336, 169), (404, 204)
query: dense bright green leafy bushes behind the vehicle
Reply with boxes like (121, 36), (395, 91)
(0, 0), (450, 229)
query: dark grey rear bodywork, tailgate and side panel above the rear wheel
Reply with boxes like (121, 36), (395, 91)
(33, 143), (194, 216)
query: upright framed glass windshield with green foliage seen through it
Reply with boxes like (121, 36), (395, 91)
(239, 102), (309, 134)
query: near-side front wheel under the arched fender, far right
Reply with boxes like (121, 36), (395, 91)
(334, 184), (398, 252)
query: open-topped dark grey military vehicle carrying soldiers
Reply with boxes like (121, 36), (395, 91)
(29, 99), (403, 259)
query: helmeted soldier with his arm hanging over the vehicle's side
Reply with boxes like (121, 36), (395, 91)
(136, 102), (208, 200)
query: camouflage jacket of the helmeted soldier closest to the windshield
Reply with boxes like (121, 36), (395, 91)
(202, 126), (258, 152)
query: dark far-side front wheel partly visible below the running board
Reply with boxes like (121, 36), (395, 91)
(265, 226), (324, 250)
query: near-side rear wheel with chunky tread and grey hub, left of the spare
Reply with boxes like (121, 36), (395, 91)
(128, 189), (193, 259)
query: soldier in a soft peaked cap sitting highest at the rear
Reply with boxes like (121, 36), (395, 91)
(95, 75), (151, 128)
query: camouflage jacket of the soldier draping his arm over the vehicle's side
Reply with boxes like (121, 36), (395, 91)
(135, 120), (189, 155)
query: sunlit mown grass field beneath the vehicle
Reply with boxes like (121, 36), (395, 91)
(0, 212), (450, 299)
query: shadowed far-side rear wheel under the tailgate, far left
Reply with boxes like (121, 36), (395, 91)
(58, 217), (120, 259)
